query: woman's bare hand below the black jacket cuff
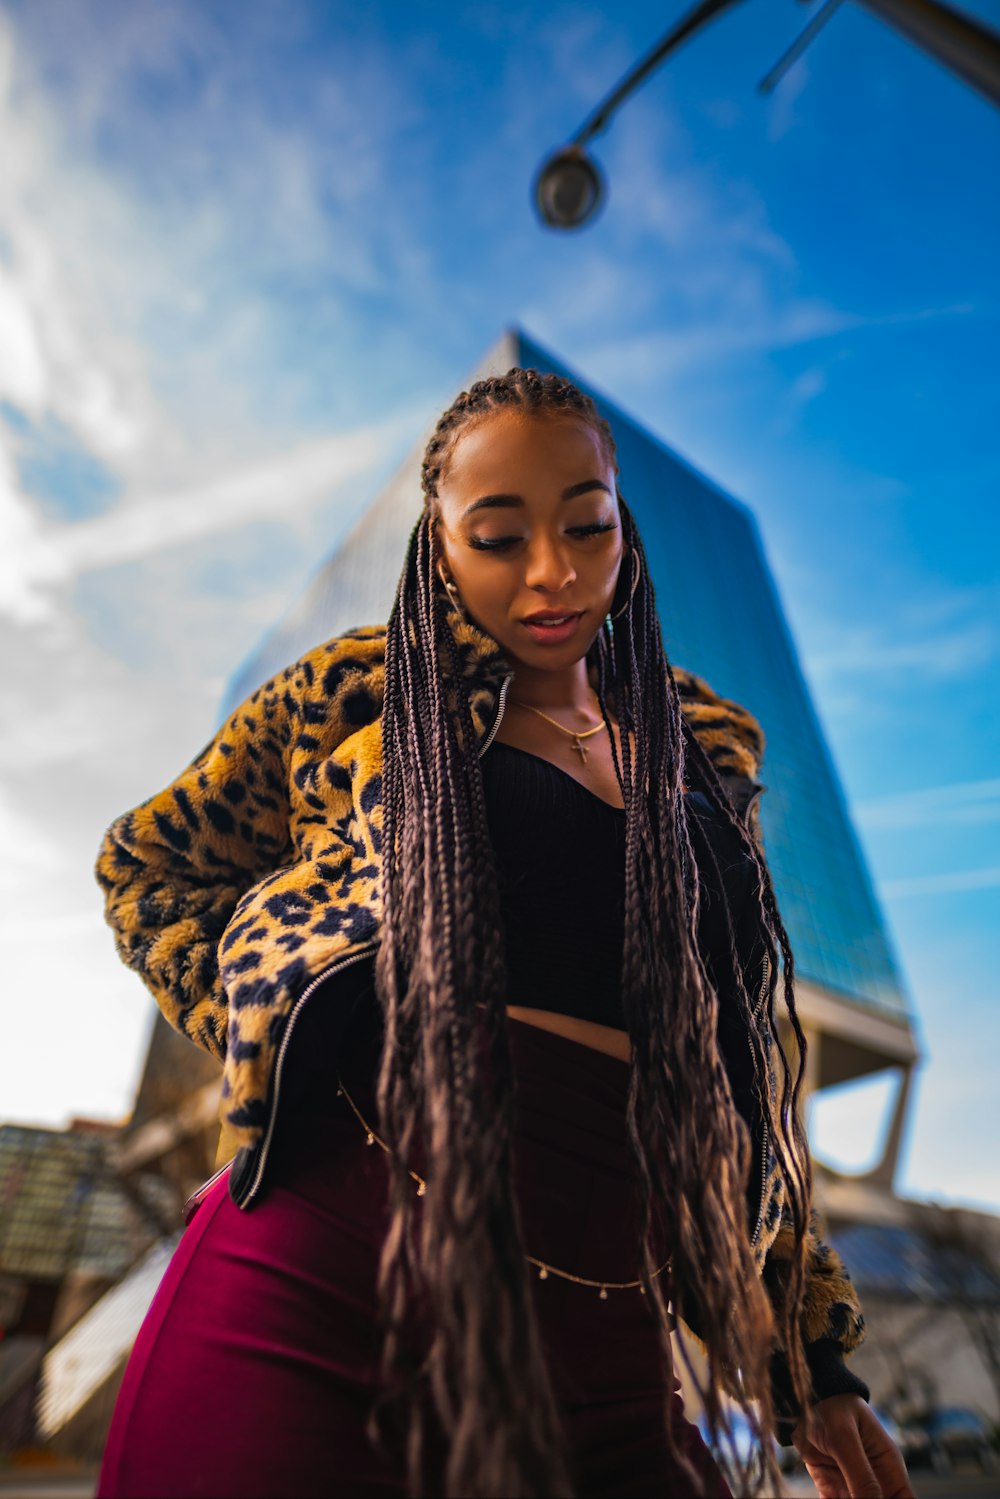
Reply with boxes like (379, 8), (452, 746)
(792, 1396), (915, 1499)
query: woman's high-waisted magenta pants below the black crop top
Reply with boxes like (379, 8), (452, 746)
(97, 1015), (732, 1499)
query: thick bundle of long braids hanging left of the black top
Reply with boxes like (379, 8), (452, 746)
(370, 494), (573, 1495)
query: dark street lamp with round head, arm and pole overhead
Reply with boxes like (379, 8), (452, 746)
(532, 0), (1000, 229)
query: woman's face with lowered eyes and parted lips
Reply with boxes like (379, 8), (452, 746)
(438, 409), (624, 669)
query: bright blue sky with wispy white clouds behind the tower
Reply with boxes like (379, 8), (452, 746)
(0, 0), (1000, 1207)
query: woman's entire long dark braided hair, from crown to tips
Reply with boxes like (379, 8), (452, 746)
(369, 367), (811, 1496)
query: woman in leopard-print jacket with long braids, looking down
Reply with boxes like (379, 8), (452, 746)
(97, 369), (910, 1499)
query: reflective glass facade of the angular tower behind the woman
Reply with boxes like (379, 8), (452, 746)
(223, 330), (909, 1019)
